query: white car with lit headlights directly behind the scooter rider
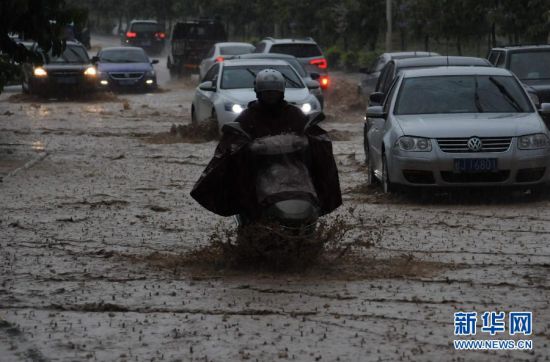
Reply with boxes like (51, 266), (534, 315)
(191, 59), (321, 129)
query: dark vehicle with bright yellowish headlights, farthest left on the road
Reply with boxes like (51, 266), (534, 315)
(22, 42), (97, 95)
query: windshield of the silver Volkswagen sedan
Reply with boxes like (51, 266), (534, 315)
(394, 75), (533, 115)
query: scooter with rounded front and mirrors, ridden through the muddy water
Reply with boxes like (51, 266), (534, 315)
(222, 112), (324, 235)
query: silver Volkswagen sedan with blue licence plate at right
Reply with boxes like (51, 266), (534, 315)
(365, 67), (550, 192)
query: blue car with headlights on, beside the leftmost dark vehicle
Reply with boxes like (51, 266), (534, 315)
(92, 47), (158, 91)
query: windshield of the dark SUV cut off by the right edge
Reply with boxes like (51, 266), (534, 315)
(510, 51), (550, 80)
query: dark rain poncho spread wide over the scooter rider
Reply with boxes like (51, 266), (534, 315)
(191, 101), (342, 216)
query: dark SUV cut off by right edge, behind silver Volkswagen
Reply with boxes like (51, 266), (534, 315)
(487, 45), (550, 106)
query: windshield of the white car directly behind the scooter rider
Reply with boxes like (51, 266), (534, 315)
(221, 65), (304, 89)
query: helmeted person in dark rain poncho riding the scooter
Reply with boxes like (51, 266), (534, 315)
(191, 69), (342, 222)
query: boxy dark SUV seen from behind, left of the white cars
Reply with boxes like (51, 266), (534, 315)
(166, 19), (227, 75)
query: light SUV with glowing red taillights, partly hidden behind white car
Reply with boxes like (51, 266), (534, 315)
(254, 37), (330, 89)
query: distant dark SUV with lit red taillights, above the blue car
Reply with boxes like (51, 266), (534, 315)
(120, 20), (166, 54)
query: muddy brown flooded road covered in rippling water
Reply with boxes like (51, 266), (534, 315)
(0, 47), (550, 361)
